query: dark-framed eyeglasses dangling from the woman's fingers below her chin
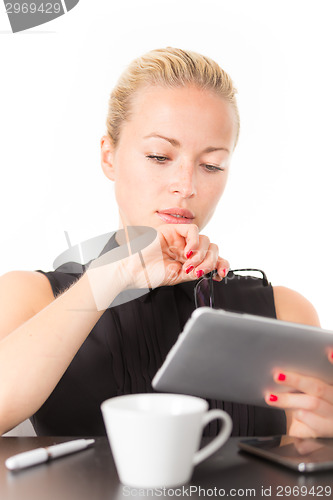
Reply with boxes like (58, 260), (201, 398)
(194, 269), (269, 309)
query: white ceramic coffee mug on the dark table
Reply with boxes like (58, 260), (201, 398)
(101, 394), (232, 488)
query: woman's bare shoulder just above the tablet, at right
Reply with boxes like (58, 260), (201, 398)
(273, 286), (320, 326)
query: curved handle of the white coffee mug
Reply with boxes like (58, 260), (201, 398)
(193, 410), (232, 465)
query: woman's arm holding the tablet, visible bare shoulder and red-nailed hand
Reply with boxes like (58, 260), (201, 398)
(266, 287), (333, 437)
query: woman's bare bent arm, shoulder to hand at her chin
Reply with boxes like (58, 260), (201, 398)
(0, 224), (229, 435)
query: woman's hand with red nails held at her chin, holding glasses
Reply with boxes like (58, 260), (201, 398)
(124, 224), (229, 288)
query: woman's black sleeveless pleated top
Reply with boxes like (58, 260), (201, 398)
(30, 234), (286, 436)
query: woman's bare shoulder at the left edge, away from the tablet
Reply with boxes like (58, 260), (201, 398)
(0, 271), (54, 339)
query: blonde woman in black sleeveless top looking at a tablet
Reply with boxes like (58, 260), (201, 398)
(0, 48), (333, 436)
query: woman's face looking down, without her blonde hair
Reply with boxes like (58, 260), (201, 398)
(101, 86), (236, 230)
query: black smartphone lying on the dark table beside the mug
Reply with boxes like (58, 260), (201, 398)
(238, 436), (333, 472)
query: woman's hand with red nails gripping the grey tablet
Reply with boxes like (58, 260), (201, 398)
(265, 349), (333, 438)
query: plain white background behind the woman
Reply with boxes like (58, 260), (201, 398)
(0, 0), (333, 329)
